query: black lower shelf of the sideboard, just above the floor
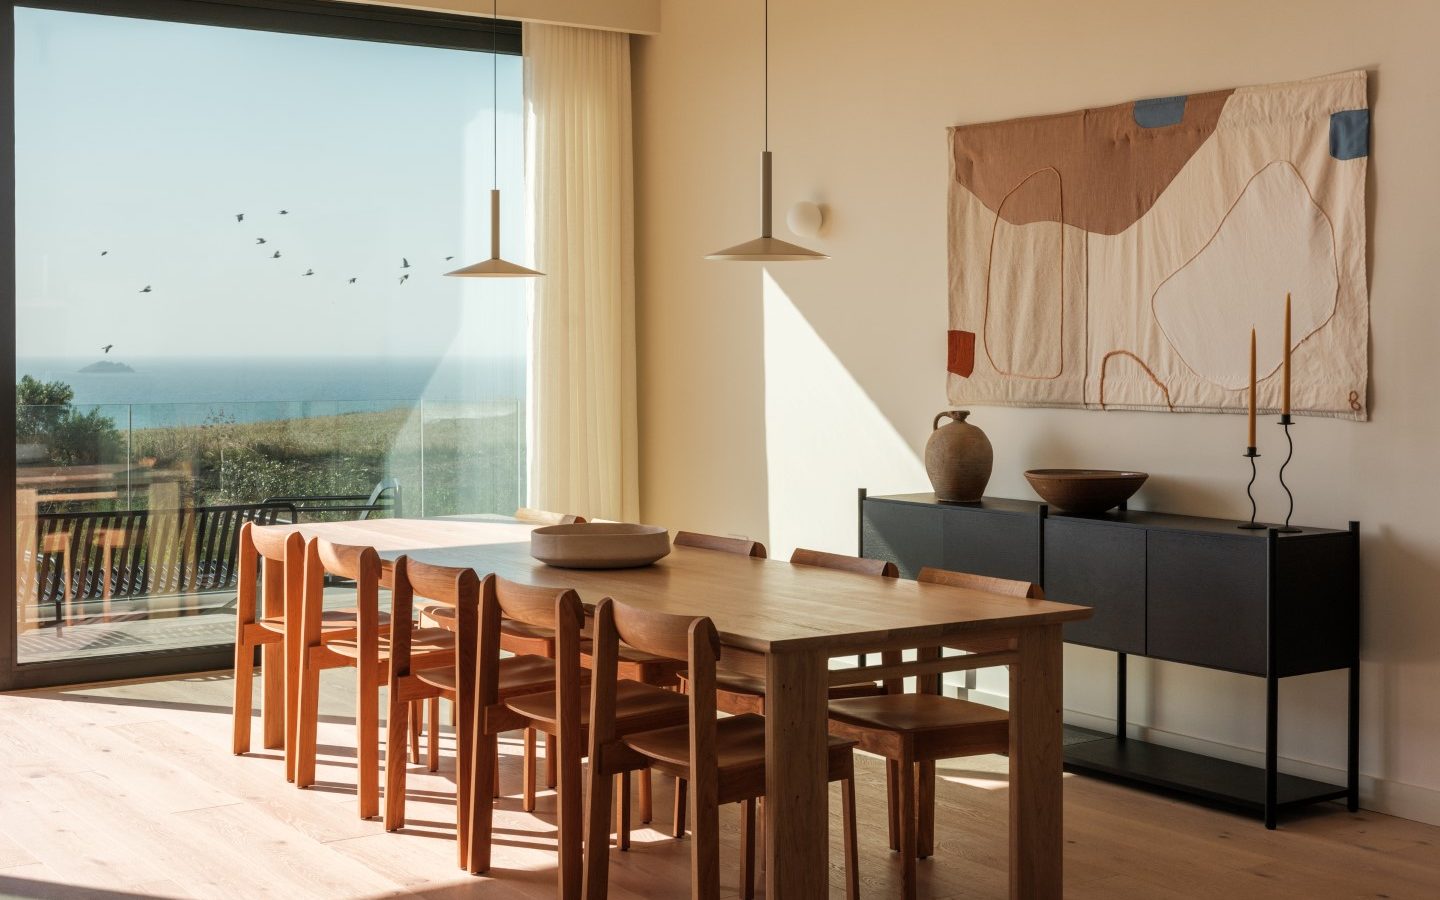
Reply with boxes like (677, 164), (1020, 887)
(1066, 727), (1349, 815)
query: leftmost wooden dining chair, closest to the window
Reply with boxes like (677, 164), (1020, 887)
(232, 523), (305, 760)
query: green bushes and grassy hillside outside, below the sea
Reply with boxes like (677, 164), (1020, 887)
(16, 376), (524, 516)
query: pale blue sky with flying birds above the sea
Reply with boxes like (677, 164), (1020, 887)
(14, 7), (527, 361)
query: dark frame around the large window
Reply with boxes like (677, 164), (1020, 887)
(0, 0), (521, 691)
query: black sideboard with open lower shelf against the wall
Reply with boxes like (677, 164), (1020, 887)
(860, 490), (1359, 828)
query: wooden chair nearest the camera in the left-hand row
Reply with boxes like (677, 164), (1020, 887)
(585, 598), (860, 900)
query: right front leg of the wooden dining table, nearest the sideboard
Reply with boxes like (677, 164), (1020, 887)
(1009, 625), (1064, 900)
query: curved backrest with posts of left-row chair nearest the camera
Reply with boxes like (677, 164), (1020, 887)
(590, 598), (720, 809)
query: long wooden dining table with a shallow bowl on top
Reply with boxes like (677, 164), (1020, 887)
(256, 516), (1090, 900)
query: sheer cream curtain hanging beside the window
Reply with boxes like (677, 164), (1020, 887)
(524, 23), (639, 521)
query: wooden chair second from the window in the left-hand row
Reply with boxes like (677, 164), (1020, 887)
(295, 539), (455, 819)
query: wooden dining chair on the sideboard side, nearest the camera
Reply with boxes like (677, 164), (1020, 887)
(829, 569), (1044, 900)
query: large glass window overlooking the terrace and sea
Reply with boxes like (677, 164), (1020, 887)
(14, 4), (526, 665)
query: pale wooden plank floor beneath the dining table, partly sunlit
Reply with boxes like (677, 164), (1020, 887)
(0, 671), (1440, 900)
